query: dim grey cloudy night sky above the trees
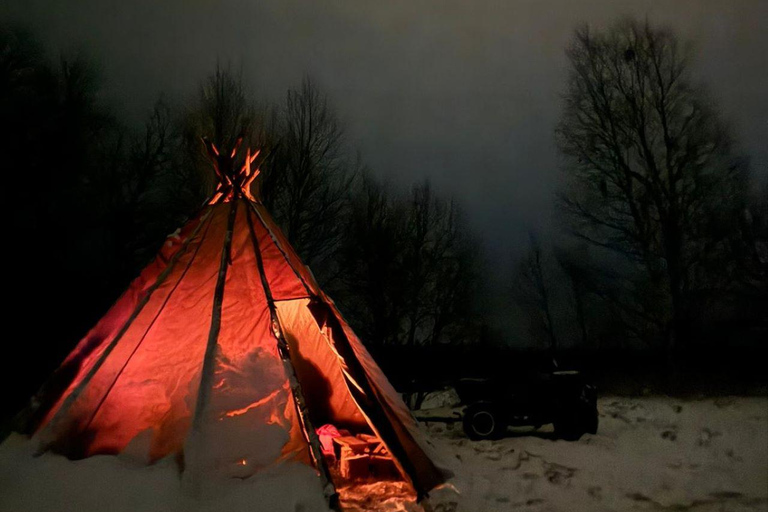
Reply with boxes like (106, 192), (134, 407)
(0, 0), (768, 267)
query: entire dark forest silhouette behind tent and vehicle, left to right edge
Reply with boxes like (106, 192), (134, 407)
(0, 22), (768, 424)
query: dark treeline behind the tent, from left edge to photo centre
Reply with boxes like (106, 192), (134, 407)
(0, 27), (478, 420)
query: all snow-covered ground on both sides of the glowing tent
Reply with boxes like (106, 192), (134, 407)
(0, 397), (768, 512)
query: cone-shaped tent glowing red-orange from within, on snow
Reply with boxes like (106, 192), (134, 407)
(16, 137), (447, 508)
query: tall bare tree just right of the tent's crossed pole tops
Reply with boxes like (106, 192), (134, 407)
(261, 77), (356, 282)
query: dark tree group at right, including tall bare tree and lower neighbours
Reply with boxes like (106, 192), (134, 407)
(515, 20), (768, 358)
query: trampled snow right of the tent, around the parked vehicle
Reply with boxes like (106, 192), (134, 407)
(427, 397), (768, 512)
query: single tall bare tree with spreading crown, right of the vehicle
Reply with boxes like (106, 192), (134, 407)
(557, 21), (746, 349)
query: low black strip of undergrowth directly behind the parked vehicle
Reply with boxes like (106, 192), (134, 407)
(374, 345), (768, 398)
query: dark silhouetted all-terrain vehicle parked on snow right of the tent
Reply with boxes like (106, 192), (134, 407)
(455, 362), (598, 441)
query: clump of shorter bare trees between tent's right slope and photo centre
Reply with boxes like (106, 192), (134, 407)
(340, 176), (480, 346)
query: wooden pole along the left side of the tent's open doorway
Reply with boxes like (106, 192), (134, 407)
(245, 203), (340, 510)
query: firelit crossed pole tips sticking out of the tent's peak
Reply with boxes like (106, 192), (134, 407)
(203, 135), (261, 204)
